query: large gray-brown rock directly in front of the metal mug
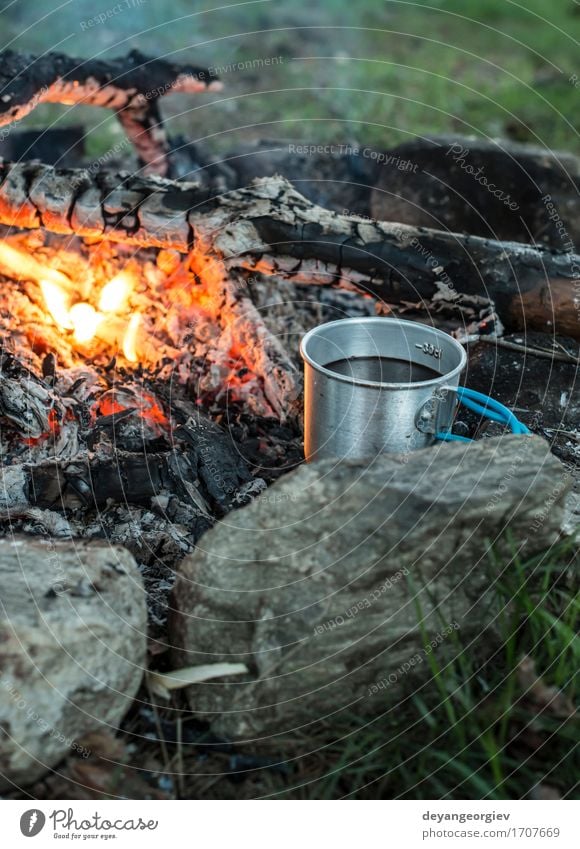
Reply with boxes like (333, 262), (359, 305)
(170, 436), (568, 738)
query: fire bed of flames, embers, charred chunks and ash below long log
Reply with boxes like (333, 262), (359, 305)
(0, 231), (300, 624)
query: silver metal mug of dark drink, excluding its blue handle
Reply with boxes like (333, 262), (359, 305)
(300, 317), (466, 461)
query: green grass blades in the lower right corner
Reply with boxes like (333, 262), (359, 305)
(275, 543), (580, 799)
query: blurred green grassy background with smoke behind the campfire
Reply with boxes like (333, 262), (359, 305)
(1, 0), (580, 157)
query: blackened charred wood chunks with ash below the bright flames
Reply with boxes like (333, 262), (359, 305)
(0, 342), (263, 529)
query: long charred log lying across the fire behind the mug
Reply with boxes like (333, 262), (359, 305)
(0, 163), (580, 338)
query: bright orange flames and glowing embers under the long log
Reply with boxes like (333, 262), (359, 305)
(0, 236), (271, 459)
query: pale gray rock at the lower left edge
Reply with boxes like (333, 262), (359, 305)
(0, 538), (146, 787)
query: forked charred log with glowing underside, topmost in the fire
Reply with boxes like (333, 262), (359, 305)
(0, 50), (221, 175)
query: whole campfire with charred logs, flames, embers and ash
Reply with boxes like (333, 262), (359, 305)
(0, 46), (578, 632)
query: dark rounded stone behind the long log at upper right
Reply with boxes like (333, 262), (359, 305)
(371, 136), (580, 243)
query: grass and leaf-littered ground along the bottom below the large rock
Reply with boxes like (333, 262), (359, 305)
(95, 540), (580, 800)
